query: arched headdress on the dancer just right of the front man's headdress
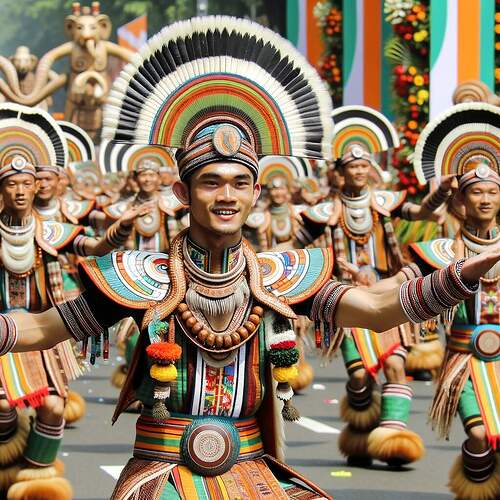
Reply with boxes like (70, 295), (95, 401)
(332, 106), (399, 182)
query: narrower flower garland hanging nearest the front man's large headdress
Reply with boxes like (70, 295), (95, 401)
(314, 0), (343, 106)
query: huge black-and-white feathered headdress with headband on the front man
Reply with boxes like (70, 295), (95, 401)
(103, 16), (333, 183)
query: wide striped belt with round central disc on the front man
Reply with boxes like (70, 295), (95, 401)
(134, 410), (264, 476)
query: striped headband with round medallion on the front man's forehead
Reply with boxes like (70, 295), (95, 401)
(176, 124), (259, 181)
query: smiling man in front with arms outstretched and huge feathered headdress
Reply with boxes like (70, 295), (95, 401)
(0, 16), (494, 499)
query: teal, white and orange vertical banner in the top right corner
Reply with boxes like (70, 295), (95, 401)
(430, 0), (495, 118)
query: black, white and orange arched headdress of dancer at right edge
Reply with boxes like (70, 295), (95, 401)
(413, 102), (500, 189)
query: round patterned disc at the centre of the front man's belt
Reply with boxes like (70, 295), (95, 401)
(180, 417), (240, 476)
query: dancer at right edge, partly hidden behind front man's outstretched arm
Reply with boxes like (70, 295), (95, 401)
(411, 103), (500, 500)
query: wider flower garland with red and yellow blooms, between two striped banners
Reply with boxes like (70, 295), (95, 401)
(384, 0), (430, 197)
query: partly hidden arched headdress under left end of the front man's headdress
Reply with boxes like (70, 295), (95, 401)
(99, 141), (175, 174)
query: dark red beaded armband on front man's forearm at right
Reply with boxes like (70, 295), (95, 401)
(399, 259), (478, 323)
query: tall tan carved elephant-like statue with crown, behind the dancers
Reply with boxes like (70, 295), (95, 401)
(0, 2), (133, 138)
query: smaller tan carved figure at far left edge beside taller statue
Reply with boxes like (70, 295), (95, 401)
(0, 45), (66, 110)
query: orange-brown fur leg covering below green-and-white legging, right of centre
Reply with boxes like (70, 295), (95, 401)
(368, 427), (425, 466)
